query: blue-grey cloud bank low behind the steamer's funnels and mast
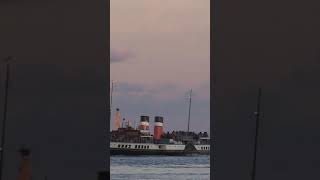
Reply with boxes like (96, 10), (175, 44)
(110, 82), (210, 131)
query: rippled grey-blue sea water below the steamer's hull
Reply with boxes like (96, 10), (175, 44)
(110, 155), (210, 180)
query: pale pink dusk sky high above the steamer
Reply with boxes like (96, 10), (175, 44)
(111, 0), (210, 130)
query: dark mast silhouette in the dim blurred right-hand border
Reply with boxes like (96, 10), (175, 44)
(251, 88), (262, 180)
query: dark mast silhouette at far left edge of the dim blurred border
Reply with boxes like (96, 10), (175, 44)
(0, 57), (12, 180)
